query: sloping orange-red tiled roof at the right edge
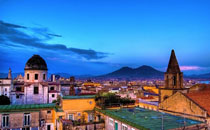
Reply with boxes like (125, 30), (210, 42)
(185, 88), (210, 115)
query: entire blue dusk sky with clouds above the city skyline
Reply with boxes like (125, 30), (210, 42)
(0, 0), (210, 75)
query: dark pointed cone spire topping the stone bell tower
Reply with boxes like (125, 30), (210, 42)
(167, 50), (181, 73)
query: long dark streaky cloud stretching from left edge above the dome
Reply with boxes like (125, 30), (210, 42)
(0, 21), (109, 60)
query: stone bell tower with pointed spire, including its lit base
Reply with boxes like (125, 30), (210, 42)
(159, 50), (187, 102)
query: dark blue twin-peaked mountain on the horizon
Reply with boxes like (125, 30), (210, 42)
(99, 65), (164, 79)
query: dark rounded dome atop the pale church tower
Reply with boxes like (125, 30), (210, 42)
(25, 55), (47, 70)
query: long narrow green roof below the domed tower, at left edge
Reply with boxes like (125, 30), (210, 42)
(0, 103), (56, 112)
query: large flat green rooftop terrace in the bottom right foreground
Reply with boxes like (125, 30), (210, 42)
(98, 108), (203, 130)
